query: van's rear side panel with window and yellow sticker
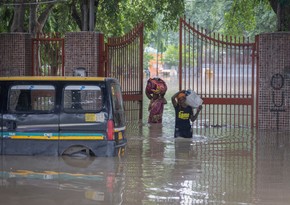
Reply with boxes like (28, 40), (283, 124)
(59, 82), (108, 154)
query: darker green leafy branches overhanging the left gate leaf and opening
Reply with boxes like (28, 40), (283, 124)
(96, 0), (183, 37)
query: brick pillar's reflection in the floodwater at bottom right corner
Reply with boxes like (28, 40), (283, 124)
(255, 131), (290, 205)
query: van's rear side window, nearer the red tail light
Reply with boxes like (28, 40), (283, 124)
(63, 85), (103, 112)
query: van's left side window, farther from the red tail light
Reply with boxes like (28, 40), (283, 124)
(8, 85), (55, 112)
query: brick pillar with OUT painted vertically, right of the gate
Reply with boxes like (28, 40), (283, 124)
(258, 32), (290, 130)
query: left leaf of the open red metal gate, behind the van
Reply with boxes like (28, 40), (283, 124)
(105, 24), (143, 121)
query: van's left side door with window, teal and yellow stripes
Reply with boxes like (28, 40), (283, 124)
(3, 82), (59, 155)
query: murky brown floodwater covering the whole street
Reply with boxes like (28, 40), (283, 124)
(0, 76), (290, 205)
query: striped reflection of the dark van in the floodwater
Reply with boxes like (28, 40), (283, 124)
(0, 156), (122, 205)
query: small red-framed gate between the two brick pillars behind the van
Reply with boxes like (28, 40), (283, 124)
(32, 33), (64, 76)
